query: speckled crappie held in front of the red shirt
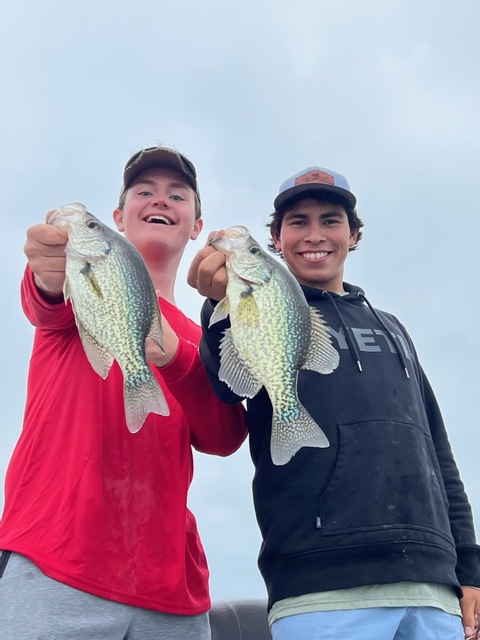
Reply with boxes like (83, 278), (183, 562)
(47, 203), (169, 433)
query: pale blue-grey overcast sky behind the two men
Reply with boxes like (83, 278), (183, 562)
(0, 0), (480, 599)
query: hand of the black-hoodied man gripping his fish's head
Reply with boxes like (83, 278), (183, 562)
(187, 231), (227, 301)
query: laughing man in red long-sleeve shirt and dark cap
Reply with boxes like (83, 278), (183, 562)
(0, 147), (246, 640)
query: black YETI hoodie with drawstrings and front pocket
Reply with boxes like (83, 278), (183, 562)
(200, 284), (480, 607)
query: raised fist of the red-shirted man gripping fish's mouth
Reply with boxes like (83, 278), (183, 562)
(24, 219), (68, 302)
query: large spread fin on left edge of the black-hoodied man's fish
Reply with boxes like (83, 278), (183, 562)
(218, 329), (263, 398)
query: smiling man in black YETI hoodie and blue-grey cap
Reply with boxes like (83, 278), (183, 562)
(189, 167), (480, 640)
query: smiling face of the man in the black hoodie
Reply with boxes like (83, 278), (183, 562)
(272, 198), (358, 293)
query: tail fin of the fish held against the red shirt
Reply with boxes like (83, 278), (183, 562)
(124, 374), (170, 433)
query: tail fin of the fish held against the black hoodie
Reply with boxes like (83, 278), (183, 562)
(270, 404), (330, 466)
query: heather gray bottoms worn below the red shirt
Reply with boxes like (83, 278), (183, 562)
(0, 552), (210, 640)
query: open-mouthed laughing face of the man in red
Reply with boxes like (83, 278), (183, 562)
(113, 167), (203, 257)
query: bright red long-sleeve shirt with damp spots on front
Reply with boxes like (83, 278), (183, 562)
(0, 267), (246, 615)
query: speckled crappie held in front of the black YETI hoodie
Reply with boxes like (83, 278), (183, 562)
(210, 226), (339, 465)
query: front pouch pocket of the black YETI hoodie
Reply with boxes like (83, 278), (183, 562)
(318, 420), (451, 539)
